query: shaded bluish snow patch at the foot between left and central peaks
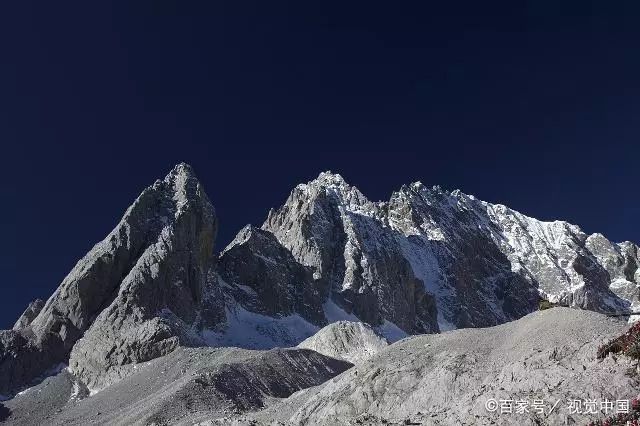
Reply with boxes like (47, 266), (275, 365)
(202, 304), (320, 349)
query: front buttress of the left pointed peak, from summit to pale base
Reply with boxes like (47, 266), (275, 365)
(69, 165), (224, 389)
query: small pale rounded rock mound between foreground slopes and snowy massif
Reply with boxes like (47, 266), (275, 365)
(298, 321), (389, 364)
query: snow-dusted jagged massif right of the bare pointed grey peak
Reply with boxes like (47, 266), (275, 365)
(250, 172), (640, 333)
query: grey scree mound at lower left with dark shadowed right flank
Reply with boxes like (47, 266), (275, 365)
(7, 348), (351, 426)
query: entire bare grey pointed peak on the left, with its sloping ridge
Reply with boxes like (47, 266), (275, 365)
(0, 164), (224, 394)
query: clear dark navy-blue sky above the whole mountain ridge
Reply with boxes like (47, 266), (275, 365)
(0, 0), (640, 327)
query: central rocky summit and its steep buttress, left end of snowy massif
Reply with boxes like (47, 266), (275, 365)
(263, 173), (438, 333)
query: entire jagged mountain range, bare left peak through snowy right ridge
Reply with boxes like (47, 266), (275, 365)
(0, 164), (640, 396)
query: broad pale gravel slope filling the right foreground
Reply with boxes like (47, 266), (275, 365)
(258, 308), (640, 425)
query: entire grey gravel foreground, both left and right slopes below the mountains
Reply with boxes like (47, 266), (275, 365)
(4, 308), (640, 426)
